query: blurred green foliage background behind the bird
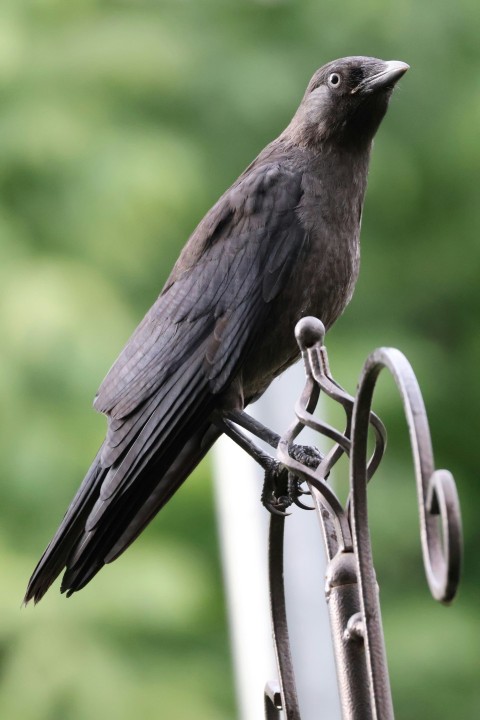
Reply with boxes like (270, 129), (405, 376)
(0, 0), (480, 720)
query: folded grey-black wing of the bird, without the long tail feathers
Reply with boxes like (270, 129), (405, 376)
(95, 164), (306, 466)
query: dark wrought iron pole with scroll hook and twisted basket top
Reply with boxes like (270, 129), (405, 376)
(265, 317), (462, 720)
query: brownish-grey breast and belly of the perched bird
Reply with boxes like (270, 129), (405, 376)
(236, 148), (368, 398)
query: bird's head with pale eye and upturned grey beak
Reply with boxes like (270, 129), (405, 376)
(288, 57), (409, 147)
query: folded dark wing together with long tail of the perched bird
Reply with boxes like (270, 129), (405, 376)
(26, 163), (306, 600)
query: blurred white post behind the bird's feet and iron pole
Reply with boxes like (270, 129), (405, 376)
(214, 364), (341, 720)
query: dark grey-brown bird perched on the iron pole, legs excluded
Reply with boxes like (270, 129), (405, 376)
(25, 57), (408, 602)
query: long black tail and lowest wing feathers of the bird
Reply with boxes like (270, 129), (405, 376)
(25, 340), (219, 602)
